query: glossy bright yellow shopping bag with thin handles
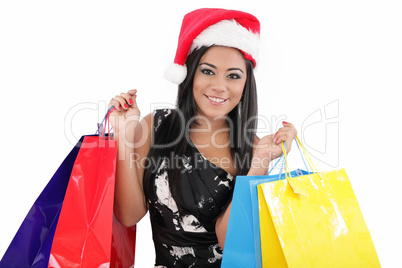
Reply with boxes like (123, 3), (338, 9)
(258, 138), (380, 268)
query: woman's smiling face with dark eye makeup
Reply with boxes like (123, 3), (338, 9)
(193, 46), (247, 119)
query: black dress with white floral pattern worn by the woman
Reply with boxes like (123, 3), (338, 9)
(148, 110), (234, 267)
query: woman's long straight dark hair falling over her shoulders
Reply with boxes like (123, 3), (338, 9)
(143, 47), (257, 214)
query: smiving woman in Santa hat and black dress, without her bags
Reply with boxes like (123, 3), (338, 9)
(110, 9), (296, 267)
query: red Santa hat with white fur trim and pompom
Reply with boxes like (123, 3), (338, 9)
(165, 8), (260, 85)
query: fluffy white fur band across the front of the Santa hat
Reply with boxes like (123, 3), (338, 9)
(190, 20), (260, 62)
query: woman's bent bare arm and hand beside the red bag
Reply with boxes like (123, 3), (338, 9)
(109, 90), (150, 226)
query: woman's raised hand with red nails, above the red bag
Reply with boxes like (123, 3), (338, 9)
(109, 89), (141, 142)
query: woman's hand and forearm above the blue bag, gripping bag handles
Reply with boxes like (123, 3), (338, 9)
(248, 121), (297, 175)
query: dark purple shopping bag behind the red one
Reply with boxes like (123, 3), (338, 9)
(0, 138), (83, 268)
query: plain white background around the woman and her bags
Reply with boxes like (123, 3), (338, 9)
(0, 0), (402, 267)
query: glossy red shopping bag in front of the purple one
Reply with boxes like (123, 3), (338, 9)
(49, 136), (135, 267)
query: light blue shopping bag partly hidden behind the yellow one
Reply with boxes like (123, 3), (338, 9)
(221, 141), (311, 268)
